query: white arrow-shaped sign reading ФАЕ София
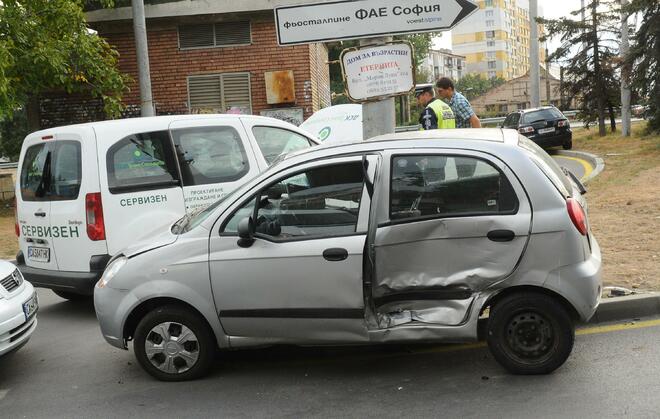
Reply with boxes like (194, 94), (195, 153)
(275, 0), (479, 45)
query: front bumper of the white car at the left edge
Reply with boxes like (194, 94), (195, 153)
(0, 282), (37, 356)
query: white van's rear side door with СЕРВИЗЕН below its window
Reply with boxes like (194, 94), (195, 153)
(96, 130), (186, 255)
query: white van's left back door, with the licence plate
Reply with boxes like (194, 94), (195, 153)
(16, 135), (57, 270)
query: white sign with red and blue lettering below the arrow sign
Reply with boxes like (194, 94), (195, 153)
(341, 43), (415, 102)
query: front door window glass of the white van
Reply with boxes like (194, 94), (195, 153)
(172, 126), (250, 186)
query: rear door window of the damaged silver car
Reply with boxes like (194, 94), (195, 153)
(390, 155), (518, 221)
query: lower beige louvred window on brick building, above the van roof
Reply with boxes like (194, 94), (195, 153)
(188, 73), (252, 114)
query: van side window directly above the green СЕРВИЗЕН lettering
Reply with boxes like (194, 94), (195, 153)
(106, 131), (180, 193)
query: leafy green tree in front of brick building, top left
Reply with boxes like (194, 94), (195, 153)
(0, 0), (127, 130)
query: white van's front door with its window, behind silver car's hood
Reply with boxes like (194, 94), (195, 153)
(169, 118), (265, 213)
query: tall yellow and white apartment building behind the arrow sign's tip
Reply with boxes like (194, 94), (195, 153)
(452, 0), (545, 80)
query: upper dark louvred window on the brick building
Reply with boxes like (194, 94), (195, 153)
(179, 21), (252, 49)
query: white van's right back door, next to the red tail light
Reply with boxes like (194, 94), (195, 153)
(50, 131), (108, 272)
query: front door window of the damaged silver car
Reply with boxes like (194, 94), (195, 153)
(223, 162), (364, 240)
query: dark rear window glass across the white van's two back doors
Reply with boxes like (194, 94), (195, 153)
(21, 141), (82, 201)
